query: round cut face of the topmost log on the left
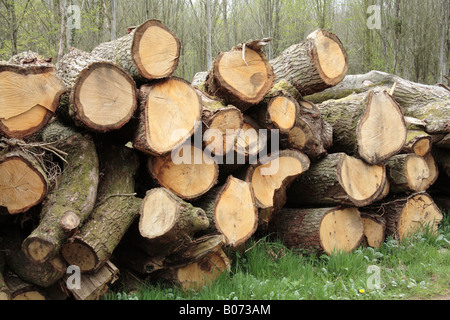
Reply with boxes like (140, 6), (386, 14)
(131, 20), (181, 80)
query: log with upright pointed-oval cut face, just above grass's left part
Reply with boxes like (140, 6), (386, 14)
(195, 176), (258, 248)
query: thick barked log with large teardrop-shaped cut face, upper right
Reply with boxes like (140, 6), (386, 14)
(319, 91), (407, 165)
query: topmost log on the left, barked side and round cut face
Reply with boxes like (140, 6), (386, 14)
(92, 20), (181, 82)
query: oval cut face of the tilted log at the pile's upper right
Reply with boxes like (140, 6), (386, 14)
(307, 29), (348, 86)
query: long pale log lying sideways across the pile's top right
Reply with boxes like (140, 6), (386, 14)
(305, 71), (450, 134)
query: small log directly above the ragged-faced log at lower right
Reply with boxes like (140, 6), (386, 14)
(386, 153), (430, 193)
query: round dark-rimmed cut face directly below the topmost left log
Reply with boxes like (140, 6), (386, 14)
(72, 62), (137, 132)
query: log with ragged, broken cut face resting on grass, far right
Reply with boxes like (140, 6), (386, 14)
(378, 193), (443, 240)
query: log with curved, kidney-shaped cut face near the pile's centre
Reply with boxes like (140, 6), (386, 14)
(245, 150), (310, 228)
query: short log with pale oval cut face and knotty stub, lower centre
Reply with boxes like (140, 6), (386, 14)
(136, 188), (209, 261)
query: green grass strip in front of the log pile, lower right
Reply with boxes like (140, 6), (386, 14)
(104, 214), (450, 300)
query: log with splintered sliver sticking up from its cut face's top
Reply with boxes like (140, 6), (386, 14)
(204, 39), (275, 112)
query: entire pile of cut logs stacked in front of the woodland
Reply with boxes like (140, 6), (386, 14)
(0, 20), (450, 300)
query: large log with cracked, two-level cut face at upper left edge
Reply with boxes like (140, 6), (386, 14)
(0, 51), (66, 139)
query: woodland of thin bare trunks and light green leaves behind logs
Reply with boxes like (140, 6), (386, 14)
(0, 0), (450, 84)
